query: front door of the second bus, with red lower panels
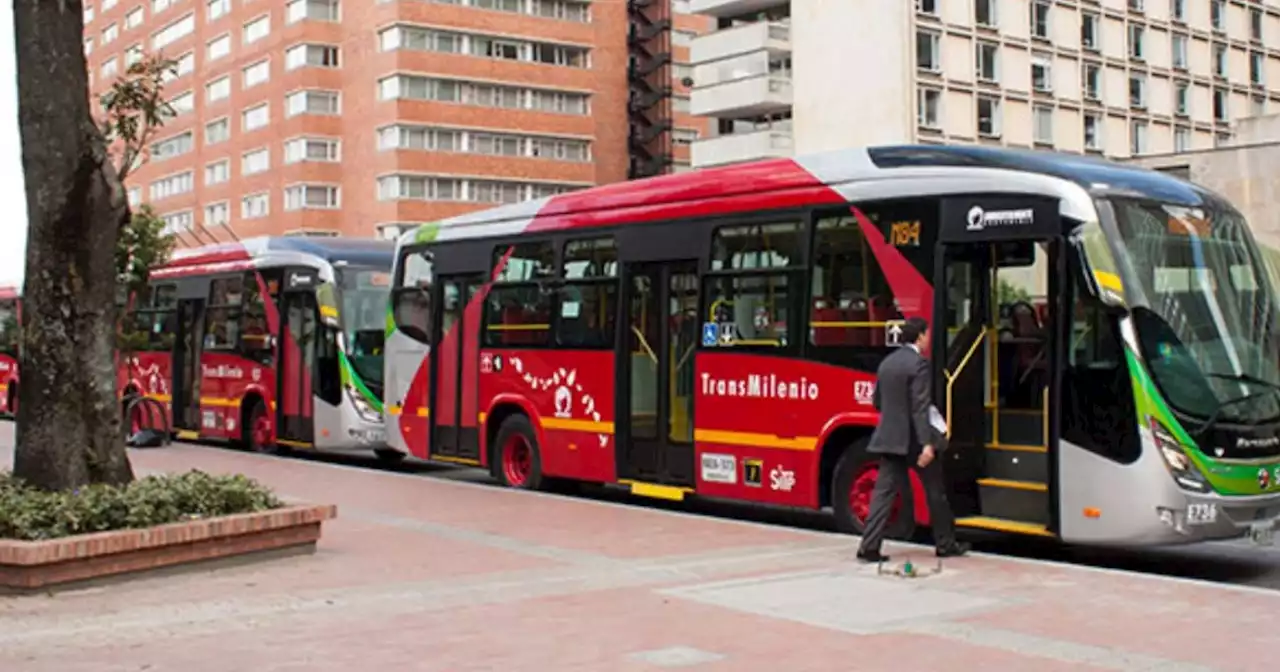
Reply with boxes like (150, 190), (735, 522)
(275, 269), (321, 448)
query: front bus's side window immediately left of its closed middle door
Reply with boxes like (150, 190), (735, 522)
(556, 238), (618, 348)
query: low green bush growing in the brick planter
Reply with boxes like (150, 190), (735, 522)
(0, 470), (283, 541)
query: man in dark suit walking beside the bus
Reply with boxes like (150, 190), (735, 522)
(858, 317), (969, 562)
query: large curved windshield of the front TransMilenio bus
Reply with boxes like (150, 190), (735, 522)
(1112, 198), (1280, 424)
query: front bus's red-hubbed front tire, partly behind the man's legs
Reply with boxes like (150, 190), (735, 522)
(831, 442), (915, 540)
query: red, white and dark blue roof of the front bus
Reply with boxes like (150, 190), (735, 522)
(399, 145), (1224, 244)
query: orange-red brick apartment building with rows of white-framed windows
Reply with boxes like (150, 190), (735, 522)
(84, 0), (705, 246)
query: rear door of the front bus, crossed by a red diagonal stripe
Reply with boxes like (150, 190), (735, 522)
(428, 274), (485, 463)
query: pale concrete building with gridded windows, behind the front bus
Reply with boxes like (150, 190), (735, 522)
(691, 0), (1280, 165)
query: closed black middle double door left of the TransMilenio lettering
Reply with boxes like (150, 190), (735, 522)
(617, 260), (700, 486)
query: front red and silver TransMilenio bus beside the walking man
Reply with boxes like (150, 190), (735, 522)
(384, 146), (1280, 545)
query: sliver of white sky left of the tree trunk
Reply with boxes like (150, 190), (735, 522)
(0, 0), (27, 285)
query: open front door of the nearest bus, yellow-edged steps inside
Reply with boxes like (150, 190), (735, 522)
(932, 196), (1066, 534)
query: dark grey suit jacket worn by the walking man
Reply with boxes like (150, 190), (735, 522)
(867, 346), (942, 456)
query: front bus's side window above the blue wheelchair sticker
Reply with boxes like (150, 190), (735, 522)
(704, 221), (804, 348)
